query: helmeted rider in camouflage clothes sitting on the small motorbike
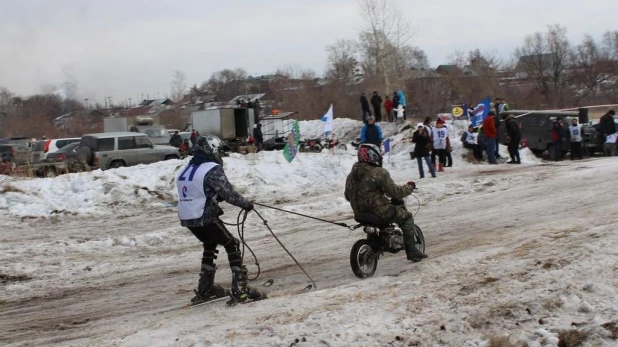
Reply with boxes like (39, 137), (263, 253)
(345, 143), (427, 262)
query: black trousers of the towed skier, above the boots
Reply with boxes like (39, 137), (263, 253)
(189, 221), (242, 268)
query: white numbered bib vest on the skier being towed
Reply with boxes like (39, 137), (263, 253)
(176, 163), (218, 220)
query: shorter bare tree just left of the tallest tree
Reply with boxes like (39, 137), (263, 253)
(326, 39), (358, 83)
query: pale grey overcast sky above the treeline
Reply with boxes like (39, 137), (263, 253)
(0, 0), (618, 103)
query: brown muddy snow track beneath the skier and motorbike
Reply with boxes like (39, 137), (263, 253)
(0, 163), (617, 346)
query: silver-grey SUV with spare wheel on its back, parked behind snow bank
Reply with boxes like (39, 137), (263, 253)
(77, 132), (180, 170)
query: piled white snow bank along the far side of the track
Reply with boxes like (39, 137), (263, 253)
(0, 118), (540, 217)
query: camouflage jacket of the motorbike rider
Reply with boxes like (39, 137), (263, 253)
(345, 162), (413, 221)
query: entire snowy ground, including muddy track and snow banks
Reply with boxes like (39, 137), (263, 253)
(0, 119), (618, 347)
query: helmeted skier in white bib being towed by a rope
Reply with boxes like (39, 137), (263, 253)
(176, 136), (265, 305)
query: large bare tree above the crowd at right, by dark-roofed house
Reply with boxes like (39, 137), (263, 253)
(515, 24), (572, 107)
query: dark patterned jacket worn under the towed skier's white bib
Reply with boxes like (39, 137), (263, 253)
(180, 165), (249, 228)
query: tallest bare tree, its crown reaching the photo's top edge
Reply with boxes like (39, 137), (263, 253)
(359, 0), (414, 93)
